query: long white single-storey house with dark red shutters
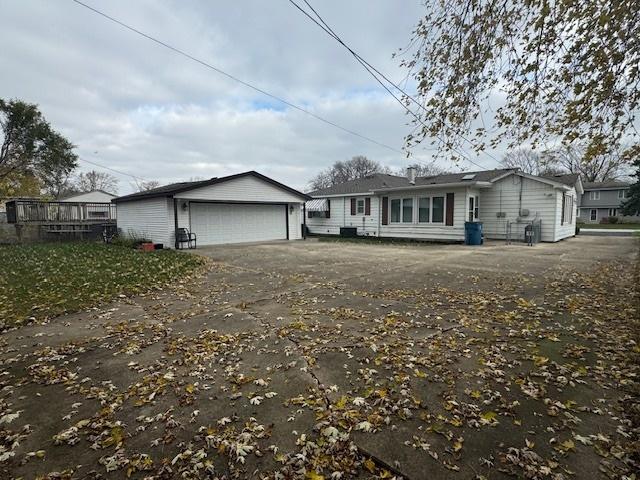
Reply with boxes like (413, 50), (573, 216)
(306, 167), (582, 242)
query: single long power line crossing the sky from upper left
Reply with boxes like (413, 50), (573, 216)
(72, 0), (406, 155)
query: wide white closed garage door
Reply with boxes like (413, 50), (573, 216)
(191, 203), (287, 245)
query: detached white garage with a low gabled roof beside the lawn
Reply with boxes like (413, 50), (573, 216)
(113, 171), (310, 248)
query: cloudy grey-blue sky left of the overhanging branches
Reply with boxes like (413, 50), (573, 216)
(0, 0), (498, 194)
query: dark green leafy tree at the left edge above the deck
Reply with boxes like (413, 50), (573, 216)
(0, 99), (78, 193)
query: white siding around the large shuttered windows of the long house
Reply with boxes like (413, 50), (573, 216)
(380, 188), (467, 241)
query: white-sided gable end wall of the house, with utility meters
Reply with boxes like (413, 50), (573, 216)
(480, 175), (564, 242)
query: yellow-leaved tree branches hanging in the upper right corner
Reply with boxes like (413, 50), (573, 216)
(400, 0), (640, 161)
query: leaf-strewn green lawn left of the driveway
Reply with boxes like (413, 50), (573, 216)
(0, 242), (204, 329)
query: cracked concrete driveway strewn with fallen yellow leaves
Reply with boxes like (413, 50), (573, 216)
(0, 237), (639, 479)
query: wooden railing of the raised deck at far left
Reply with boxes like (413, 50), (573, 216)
(6, 200), (116, 224)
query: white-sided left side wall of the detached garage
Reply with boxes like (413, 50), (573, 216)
(117, 197), (173, 247)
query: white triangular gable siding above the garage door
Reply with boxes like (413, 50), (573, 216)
(180, 175), (303, 203)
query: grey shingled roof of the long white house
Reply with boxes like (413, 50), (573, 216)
(309, 168), (515, 197)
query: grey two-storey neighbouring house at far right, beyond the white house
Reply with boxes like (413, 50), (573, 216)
(580, 180), (630, 223)
